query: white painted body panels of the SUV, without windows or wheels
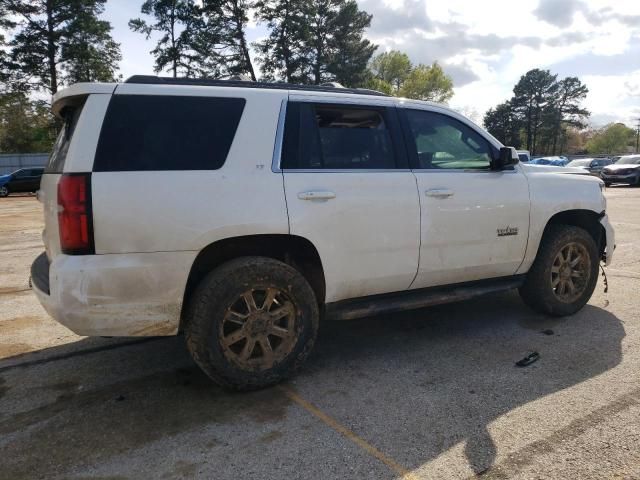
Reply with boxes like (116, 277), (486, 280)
(34, 79), (614, 336)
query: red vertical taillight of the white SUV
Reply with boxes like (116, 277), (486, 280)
(58, 173), (95, 255)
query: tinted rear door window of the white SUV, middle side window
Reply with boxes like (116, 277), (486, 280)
(281, 103), (398, 170)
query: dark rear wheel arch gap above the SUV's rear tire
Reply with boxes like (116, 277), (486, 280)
(180, 234), (326, 330)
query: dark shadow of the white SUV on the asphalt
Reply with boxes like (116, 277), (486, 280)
(0, 293), (624, 479)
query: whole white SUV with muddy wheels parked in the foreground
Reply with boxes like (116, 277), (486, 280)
(31, 76), (614, 389)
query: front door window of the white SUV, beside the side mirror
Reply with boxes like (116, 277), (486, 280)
(406, 110), (493, 170)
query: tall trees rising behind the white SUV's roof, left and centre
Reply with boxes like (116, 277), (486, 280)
(0, 0), (460, 153)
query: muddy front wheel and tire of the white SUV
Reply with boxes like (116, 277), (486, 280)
(520, 225), (599, 316)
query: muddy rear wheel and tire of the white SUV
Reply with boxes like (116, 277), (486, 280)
(185, 257), (319, 391)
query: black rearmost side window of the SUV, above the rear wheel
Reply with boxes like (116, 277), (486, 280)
(93, 95), (245, 172)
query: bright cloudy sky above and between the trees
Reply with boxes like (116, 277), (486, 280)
(103, 0), (640, 127)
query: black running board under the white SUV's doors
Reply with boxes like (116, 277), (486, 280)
(325, 275), (525, 320)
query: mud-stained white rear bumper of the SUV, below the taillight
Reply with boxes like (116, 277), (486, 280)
(31, 252), (197, 336)
